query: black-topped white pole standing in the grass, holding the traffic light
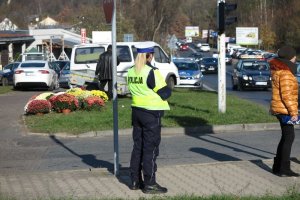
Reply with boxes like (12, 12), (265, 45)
(217, 0), (226, 113)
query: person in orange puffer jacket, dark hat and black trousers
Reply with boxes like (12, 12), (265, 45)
(269, 45), (299, 177)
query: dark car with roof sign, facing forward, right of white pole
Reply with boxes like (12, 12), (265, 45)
(231, 59), (271, 91)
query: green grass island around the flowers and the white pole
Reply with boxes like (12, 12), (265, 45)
(25, 89), (277, 134)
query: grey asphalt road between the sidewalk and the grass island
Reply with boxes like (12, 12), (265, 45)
(0, 91), (300, 173)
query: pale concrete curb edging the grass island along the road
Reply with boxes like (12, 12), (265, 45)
(25, 123), (288, 138)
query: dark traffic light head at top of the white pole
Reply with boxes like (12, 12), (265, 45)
(217, 0), (237, 34)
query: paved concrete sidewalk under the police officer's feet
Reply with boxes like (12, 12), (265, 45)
(0, 159), (300, 200)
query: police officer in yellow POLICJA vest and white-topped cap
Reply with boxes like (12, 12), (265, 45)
(127, 42), (171, 194)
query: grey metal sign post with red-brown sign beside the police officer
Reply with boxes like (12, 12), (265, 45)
(103, 0), (119, 176)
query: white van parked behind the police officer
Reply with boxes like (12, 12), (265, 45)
(70, 42), (180, 88)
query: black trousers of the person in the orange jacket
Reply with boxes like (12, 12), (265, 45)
(275, 118), (295, 170)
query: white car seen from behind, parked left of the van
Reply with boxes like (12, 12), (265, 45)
(13, 60), (59, 90)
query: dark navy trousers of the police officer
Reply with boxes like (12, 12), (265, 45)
(130, 108), (161, 185)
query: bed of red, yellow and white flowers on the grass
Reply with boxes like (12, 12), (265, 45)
(24, 88), (108, 114)
